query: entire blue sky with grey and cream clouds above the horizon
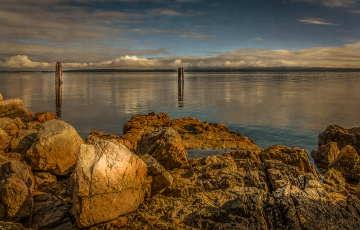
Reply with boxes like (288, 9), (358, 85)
(0, 0), (360, 71)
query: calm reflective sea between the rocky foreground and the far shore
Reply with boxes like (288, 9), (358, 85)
(0, 72), (360, 162)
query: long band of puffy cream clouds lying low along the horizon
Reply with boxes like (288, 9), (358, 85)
(0, 41), (360, 70)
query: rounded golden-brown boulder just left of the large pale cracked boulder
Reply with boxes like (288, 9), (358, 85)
(26, 120), (83, 175)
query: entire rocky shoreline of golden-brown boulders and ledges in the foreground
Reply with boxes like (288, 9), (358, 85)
(0, 94), (360, 230)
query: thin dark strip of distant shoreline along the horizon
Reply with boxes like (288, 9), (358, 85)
(0, 67), (360, 73)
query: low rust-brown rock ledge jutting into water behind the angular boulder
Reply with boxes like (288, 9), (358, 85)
(120, 113), (261, 152)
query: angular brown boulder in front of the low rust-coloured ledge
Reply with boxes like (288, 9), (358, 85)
(136, 128), (187, 169)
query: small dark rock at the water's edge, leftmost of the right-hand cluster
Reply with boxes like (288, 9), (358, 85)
(311, 142), (340, 169)
